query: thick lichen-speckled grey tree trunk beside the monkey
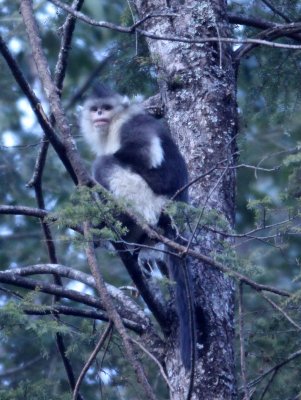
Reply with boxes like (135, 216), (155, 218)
(135, 0), (236, 400)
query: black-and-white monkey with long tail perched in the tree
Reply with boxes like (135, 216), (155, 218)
(80, 83), (193, 370)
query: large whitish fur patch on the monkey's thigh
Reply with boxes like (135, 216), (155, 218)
(110, 166), (167, 225)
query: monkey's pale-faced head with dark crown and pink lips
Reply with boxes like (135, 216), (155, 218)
(80, 84), (129, 153)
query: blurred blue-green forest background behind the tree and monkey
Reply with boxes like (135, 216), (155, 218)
(0, 0), (301, 400)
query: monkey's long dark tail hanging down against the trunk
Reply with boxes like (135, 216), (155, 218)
(169, 255), (196, 373)
